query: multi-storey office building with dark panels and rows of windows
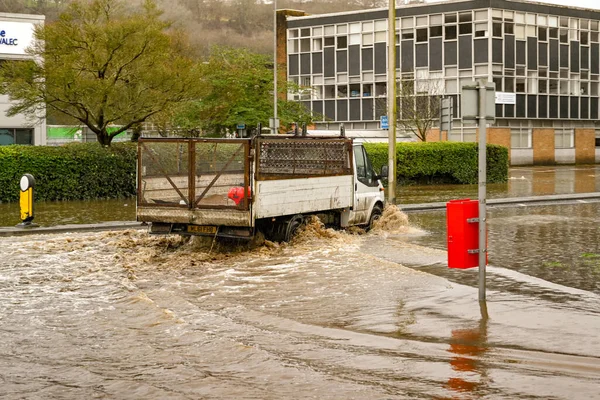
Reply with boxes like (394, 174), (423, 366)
(278, 0), (600, 164)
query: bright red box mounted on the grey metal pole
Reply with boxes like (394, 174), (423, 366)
(446, 199), (487, 269)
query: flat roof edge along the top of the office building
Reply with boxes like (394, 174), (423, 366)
(287, 0), (600, 28)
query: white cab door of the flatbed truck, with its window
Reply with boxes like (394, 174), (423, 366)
(353, 145), (379, 224)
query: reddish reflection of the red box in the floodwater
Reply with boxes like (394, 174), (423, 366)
(447, 301), (489, 394)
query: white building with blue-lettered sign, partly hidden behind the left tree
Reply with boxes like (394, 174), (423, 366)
(0, 13), (46, 145)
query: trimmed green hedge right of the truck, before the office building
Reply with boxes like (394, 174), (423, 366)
(365, 142), (508, 184)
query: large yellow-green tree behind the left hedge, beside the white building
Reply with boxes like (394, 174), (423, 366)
(0, 0), (204, 146)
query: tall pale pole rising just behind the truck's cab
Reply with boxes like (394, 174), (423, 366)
(388, 0), (396, 204)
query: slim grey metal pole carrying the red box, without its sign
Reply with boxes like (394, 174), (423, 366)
(478, 81), (487, 301)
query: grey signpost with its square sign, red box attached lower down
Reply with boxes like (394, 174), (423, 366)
(461, 81), (496, 301)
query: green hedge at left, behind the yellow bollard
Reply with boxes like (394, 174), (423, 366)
(0, 143), (136, 202)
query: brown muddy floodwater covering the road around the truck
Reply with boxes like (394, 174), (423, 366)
(0, 210), (600, 399)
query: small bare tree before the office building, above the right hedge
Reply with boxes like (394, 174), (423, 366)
(396, 75), (444, 142)
